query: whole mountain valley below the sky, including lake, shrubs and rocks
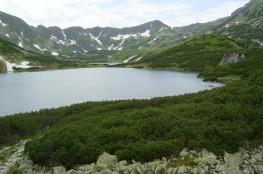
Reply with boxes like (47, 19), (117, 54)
(0, 0), (263, 174)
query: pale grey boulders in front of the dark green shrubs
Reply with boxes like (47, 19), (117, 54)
(0, 142), (263, 174)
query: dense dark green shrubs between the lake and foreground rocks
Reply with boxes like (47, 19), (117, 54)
(0, 36), (263, 167)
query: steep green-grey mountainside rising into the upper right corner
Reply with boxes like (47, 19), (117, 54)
(216, 0), (263, 42)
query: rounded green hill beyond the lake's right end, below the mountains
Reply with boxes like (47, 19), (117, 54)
(131, 35), (242, 78)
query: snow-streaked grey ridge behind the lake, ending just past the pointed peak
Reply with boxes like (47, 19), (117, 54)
(0, 12), (171, 56)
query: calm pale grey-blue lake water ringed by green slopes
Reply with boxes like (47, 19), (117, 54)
(0, 68), (222, 116)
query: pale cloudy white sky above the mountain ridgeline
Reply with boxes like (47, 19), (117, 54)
(0, 0), (249, 28)
